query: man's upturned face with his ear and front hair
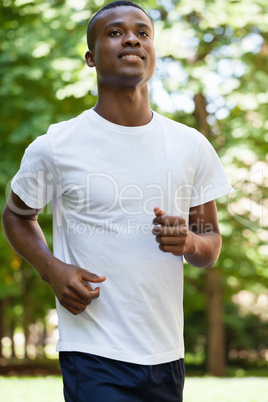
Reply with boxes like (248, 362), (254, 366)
(86, 6), (156, 87)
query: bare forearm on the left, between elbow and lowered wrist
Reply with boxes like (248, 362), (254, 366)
(2, 207), (55, 280)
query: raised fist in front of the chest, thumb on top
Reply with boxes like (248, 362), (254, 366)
(152, 207), (194, 256)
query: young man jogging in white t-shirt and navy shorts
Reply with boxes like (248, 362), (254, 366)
(3, 1), (231, 402)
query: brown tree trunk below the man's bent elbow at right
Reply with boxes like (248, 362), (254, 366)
(206, 268), (226, 376)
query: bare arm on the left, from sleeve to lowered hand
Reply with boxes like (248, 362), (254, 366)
(2, 192), (106, 314)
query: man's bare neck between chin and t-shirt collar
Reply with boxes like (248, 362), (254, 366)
(94, 86), (152, 127)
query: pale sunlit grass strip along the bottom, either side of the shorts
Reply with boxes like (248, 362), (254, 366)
(0, 376), (268, 402)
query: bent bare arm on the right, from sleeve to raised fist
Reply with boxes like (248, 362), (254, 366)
(153, 201), (221, 268)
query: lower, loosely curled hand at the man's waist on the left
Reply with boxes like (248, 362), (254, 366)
(47, 259), (106, 315)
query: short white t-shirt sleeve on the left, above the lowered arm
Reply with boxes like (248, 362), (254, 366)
(11, 134), (59, 209)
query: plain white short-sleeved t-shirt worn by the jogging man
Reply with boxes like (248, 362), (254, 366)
(12, 109), (232, 364)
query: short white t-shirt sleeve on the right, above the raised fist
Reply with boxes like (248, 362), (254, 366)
(190, 135), (233, 207)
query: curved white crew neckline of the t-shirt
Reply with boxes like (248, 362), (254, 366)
(87, 108), (156, 134)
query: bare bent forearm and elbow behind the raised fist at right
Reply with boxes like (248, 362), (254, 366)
(184, 232), (222, 268)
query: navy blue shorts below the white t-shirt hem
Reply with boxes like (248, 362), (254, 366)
(59, 352), (185, 402)
